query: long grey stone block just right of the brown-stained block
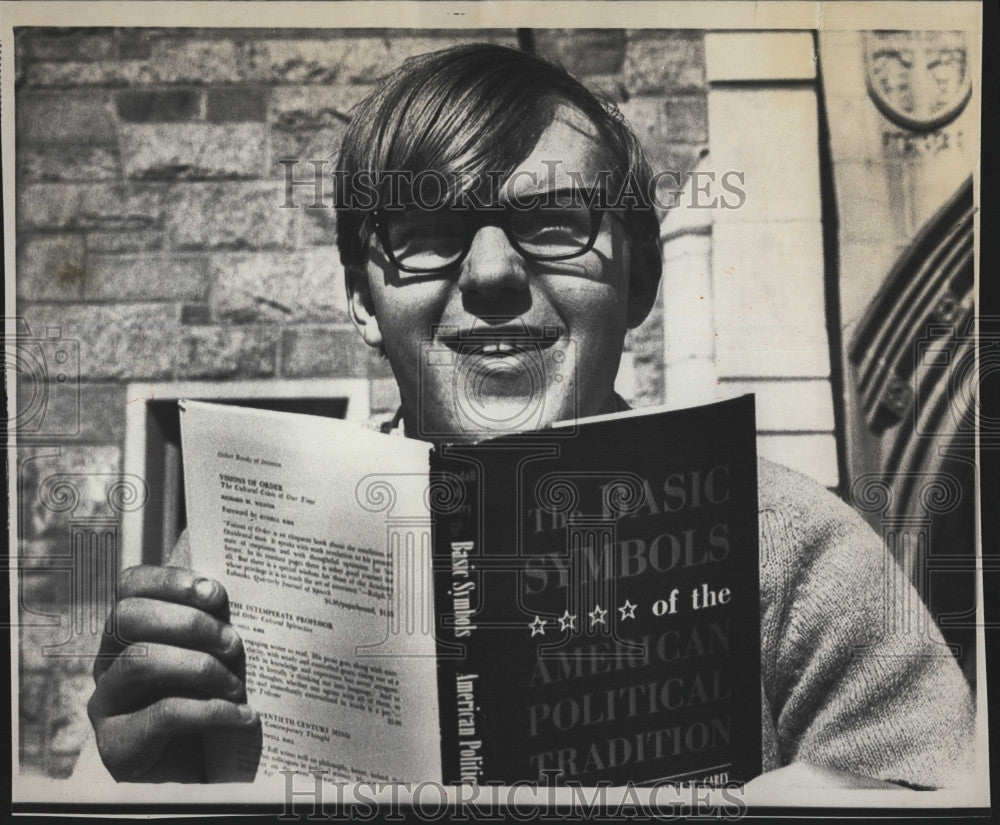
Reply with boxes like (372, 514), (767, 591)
(84, 255), (208, 301)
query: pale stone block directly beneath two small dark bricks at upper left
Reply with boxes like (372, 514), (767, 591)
(119, 123), (267, 180)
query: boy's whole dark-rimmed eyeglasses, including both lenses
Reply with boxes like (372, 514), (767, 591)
(371, 190), (611, 274)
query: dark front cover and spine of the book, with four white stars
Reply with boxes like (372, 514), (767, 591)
(431, 396), (761, 786)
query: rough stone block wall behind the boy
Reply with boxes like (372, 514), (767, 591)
(9, 29), (708, 776)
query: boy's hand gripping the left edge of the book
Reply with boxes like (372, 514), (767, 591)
(87, 566), (258, 782)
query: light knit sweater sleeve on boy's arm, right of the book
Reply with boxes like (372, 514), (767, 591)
(760, 461), (974, 788)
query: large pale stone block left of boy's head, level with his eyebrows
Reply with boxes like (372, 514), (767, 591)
(167, 183), (296, 250)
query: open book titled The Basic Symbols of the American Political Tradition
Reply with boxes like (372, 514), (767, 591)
(180, 396), (761, 786)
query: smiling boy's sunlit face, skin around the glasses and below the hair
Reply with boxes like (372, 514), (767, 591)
(352, 105), (652, 440)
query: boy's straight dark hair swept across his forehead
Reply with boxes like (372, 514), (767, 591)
(336, 43), (661, 288)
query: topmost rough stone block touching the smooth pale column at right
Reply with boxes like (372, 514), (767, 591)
(622, 31), (705, 95)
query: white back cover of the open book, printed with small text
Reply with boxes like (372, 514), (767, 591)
(180, 401), (440, 788)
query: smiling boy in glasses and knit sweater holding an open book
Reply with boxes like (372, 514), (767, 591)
(88, 41), (973, 787)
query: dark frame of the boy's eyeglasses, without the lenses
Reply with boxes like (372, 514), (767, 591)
(363, 189), (618, 275)
